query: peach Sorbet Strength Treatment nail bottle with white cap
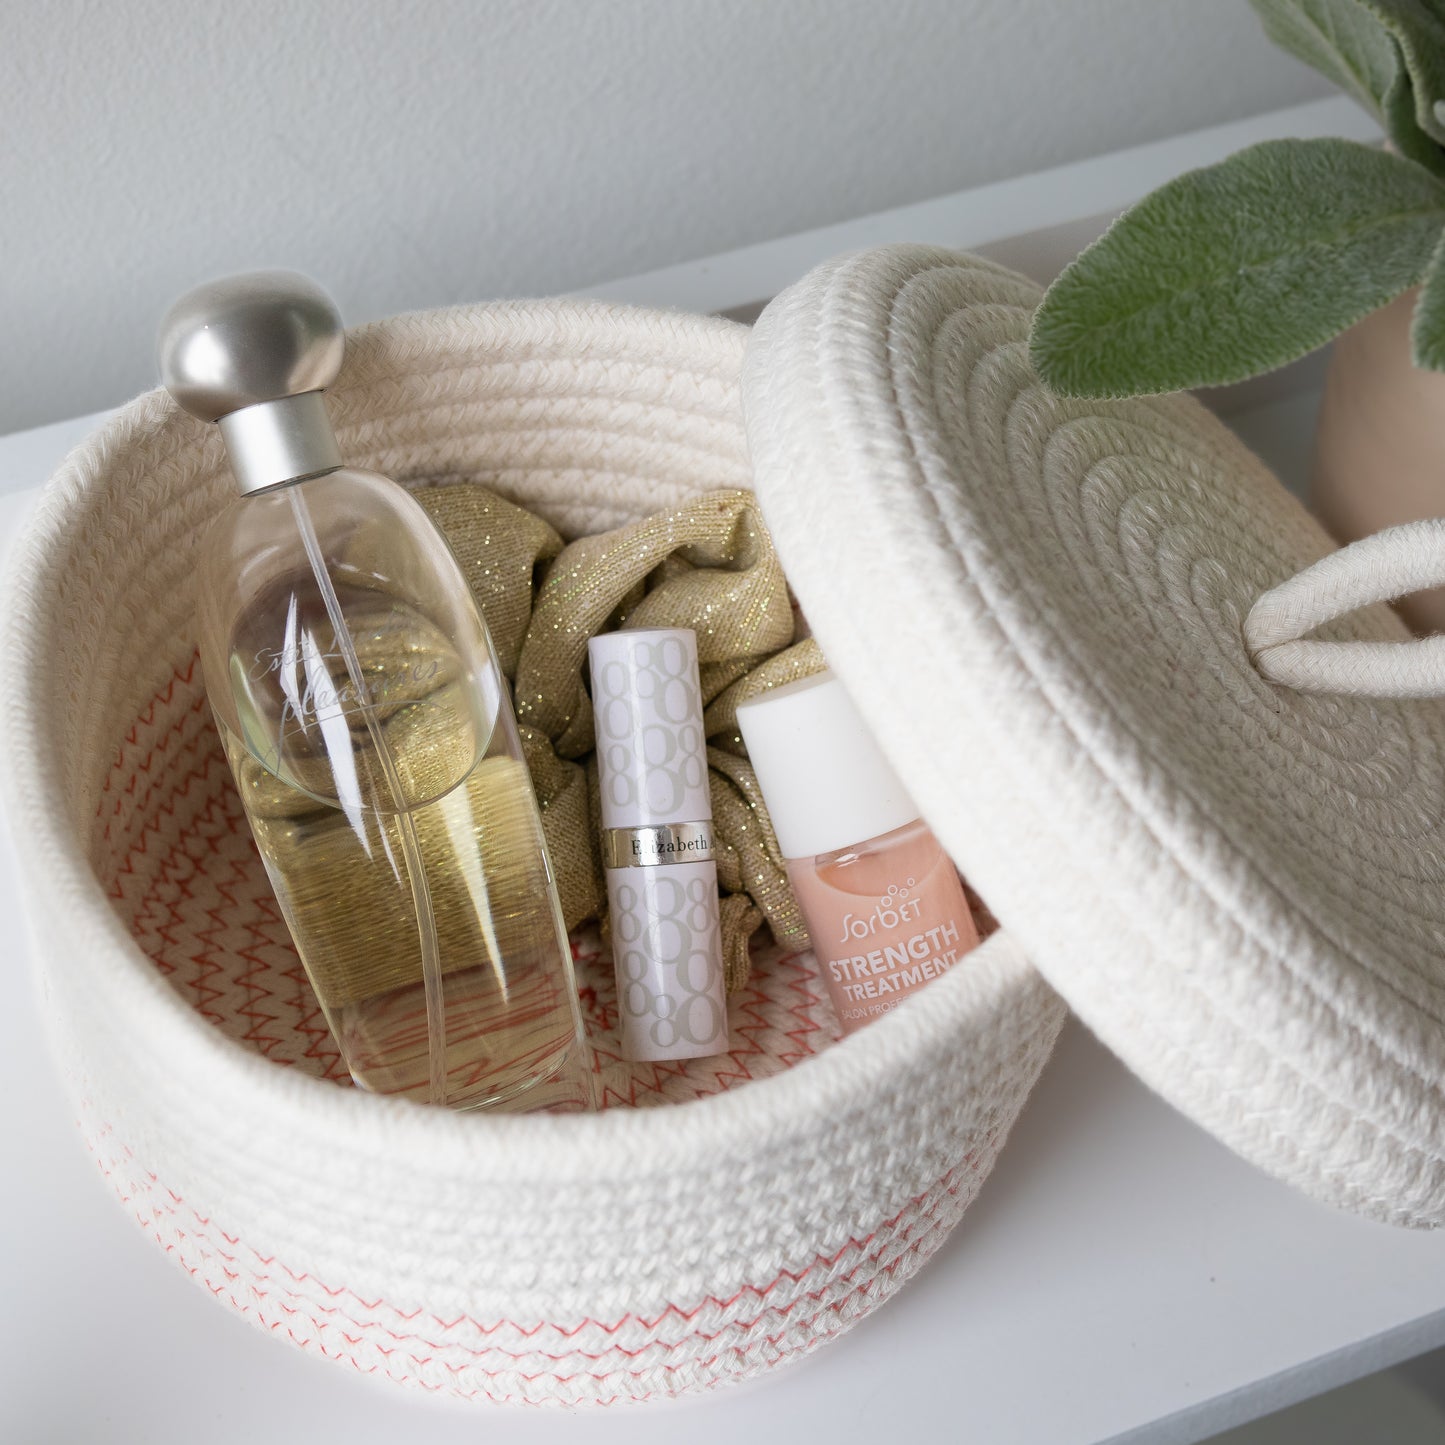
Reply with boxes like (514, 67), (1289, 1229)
(737, 672), (978, 1033)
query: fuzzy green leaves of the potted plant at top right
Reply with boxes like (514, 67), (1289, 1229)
(1030, 0), (1445, 396)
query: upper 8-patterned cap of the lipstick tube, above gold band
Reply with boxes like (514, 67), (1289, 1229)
(587, 627), (712, 828)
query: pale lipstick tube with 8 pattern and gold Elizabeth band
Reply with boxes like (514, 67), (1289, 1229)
(588, 627), (727, 1061)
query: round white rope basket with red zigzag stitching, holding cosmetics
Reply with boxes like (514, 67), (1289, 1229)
(6, 302), (1064, 1403)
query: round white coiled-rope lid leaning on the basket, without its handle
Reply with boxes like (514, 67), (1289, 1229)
(744, 247), (1445, 1225)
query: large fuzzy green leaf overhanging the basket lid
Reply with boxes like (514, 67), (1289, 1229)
(1030, 140), (1445, 396)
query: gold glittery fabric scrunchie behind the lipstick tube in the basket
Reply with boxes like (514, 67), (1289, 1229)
(415, 484), (824, 993)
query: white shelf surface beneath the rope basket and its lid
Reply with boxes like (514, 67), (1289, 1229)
(0, 103), (1445, 1445)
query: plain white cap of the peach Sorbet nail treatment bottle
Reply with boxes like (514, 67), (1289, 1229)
(737, 672), (919, 858)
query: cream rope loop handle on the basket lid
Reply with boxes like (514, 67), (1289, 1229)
(1244, 517), (1445, 698)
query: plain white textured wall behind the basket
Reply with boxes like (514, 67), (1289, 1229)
(0, 0), (1325, 432)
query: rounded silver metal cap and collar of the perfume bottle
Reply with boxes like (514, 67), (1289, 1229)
(158, 272), (345, 491)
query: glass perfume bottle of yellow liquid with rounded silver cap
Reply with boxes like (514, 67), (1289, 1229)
(160, 272), (592, 1108)
